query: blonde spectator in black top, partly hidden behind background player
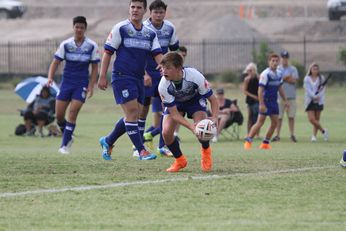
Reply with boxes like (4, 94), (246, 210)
(243, 63), (260, 137)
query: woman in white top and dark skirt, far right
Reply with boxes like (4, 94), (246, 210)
(304, 63), (329, 142)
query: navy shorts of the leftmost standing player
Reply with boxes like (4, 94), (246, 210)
(56, 82), (88, 103)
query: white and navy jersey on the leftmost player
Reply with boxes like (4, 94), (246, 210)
(54, 37), (100, 85)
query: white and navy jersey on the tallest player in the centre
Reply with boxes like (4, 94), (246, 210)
(104, 19), (162, 78)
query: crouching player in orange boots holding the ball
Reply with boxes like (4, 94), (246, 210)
(159, 52), (219, 172)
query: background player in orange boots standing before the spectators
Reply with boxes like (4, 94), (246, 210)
(244, 54), (288, 149)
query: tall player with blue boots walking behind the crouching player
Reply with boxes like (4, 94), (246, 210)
(98, 0), (162, 160)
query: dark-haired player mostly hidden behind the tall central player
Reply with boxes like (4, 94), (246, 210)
(138, 0), (179, 156)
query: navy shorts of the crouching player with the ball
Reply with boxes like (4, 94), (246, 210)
(164, 98), (207, 119)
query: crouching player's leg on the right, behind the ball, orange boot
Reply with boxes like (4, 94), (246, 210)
(192, 111), (213, 172)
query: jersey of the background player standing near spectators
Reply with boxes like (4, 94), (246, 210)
(258, 67), (282, 102)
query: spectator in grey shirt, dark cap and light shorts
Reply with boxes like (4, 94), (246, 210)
(272, 51), (299, 142)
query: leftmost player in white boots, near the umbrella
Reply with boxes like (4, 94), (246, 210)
(48, 16), (100, 154)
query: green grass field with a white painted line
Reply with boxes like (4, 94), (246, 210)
(0, 87), (346, 230)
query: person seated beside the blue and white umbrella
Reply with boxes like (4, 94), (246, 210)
(21, 86), (55, 137)
